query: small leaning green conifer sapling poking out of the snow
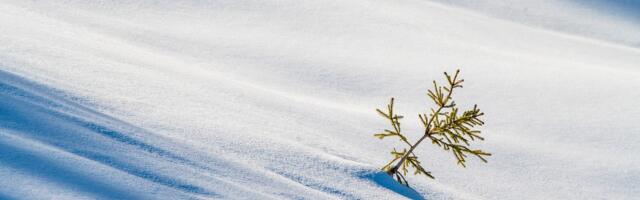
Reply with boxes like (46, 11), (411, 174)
(374, 70), (491, 185)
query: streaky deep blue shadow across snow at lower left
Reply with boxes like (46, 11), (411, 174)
(0, 70), (216, 199)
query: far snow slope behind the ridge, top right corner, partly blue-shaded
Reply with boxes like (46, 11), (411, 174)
(424, 0), (640, 47)
